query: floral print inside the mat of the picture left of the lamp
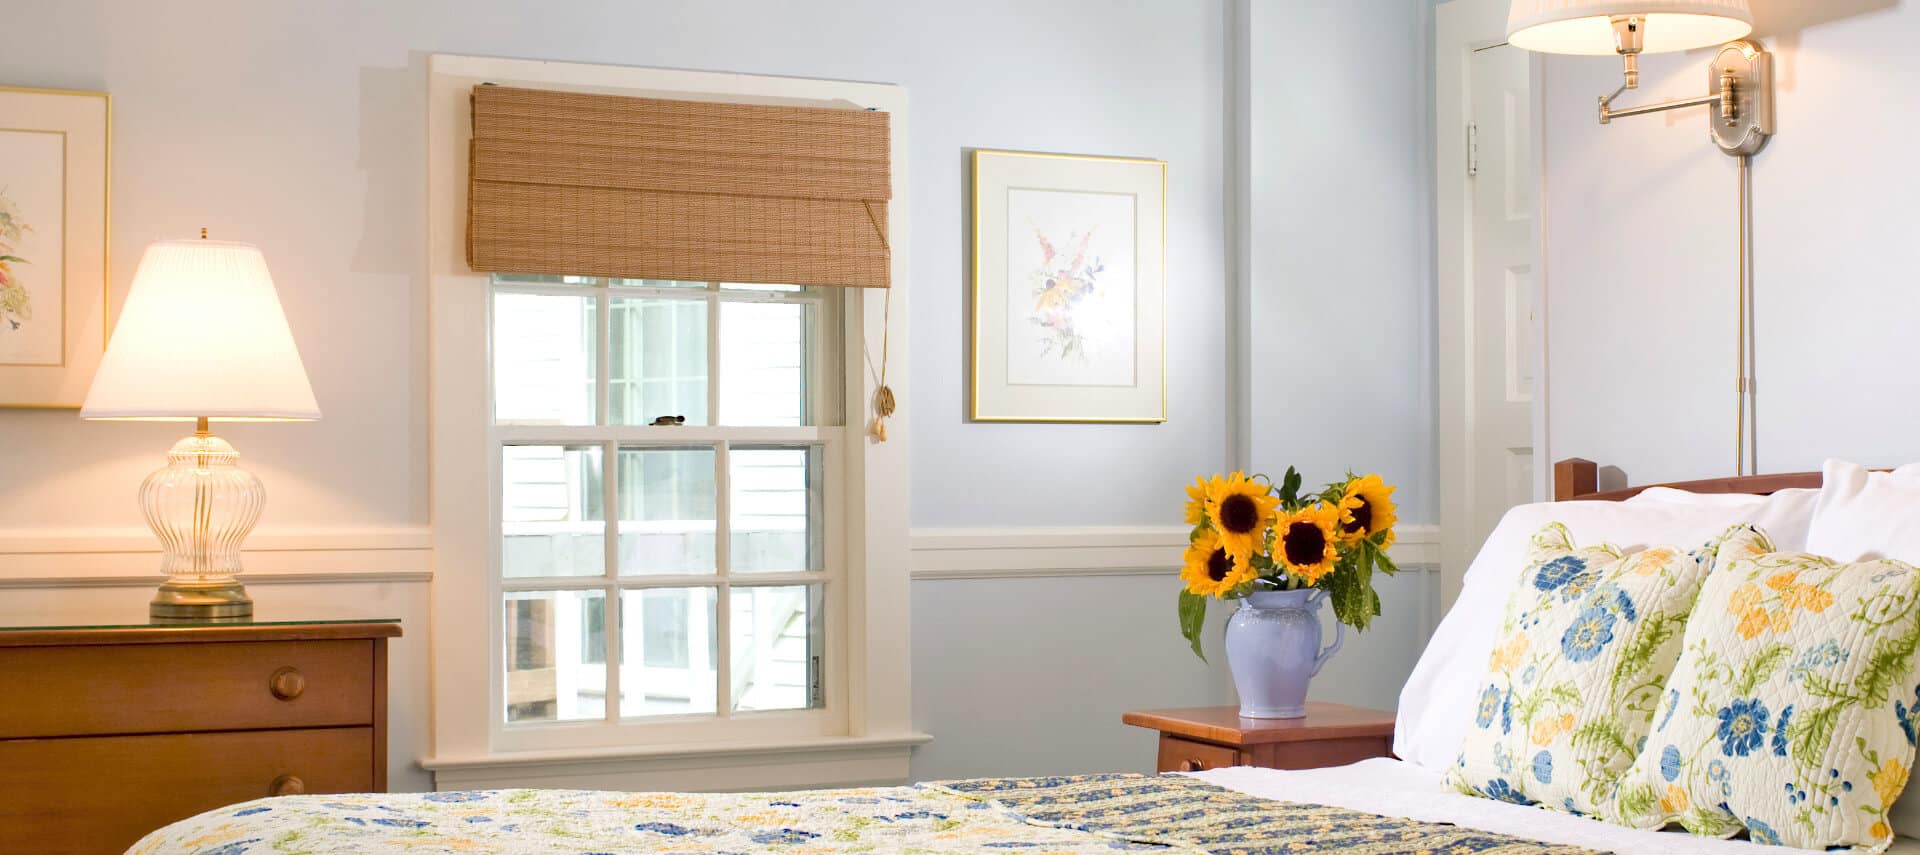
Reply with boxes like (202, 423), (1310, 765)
(0, 131), (65, 365)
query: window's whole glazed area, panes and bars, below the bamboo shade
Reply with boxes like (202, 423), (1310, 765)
(492, 275), (845, 730)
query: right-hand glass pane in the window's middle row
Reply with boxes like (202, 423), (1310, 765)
(728, 446), (826, 573)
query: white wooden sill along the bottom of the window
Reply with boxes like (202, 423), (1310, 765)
(420, 732), (931, 792)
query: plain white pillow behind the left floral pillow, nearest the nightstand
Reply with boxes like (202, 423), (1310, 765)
(1394, 490), (1812, 772)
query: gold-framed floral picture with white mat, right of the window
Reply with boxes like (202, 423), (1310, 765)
(972, 150), (1167, 423)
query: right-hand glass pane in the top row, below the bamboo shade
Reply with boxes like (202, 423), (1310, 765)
(720, 302), (814, 427)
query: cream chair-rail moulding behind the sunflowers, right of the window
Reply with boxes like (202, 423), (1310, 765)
(910, 525), (1440, 580)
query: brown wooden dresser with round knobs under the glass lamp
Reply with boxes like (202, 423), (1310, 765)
(0, 621), (399, 855)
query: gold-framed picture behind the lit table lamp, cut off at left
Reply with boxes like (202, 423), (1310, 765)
(0, 86), (111, 407)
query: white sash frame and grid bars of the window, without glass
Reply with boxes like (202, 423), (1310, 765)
(488, 277), (847, 749)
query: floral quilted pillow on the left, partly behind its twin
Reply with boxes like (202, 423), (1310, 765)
(1448, 523), (1747, 815)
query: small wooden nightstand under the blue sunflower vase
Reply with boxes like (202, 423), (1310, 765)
(1119, 703), (1394, 772)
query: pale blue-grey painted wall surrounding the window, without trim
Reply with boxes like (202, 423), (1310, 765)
(0, 0), (1434, 788)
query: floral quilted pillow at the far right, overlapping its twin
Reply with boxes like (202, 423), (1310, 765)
(1609, 534), (1920, 851)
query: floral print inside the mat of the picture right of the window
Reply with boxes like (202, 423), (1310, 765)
(1006, 188), (1137, 386)
